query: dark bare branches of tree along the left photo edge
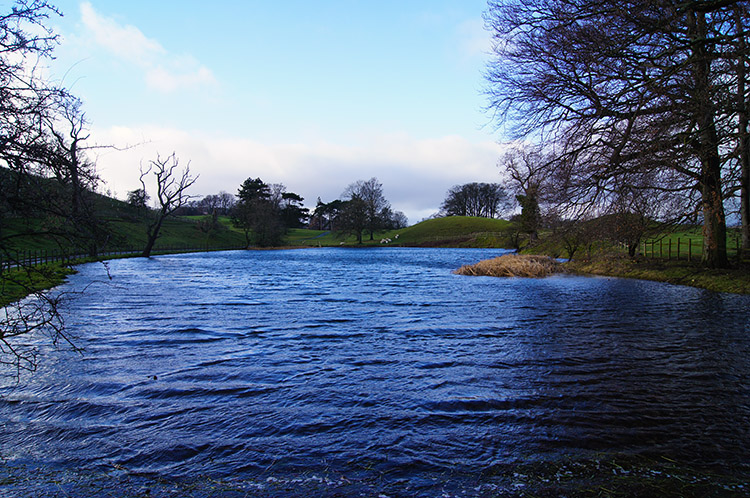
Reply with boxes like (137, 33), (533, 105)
(0, 0), (90, 377)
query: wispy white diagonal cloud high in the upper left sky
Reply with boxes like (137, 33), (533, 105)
(81, 2), (216, 92)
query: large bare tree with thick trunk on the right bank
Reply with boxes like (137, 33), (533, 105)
(486, 0), (743, 266)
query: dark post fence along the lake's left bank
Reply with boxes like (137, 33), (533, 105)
(0, 246), (245, 275)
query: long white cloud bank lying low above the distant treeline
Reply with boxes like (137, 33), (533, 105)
(94, 126), (502, 223)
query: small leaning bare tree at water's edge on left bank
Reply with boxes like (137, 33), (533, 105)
(140, 152), (198, 258)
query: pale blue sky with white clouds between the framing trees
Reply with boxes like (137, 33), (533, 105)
(42, 0), (502, 223)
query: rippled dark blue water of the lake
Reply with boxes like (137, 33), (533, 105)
(0, 248), (750, 494)
